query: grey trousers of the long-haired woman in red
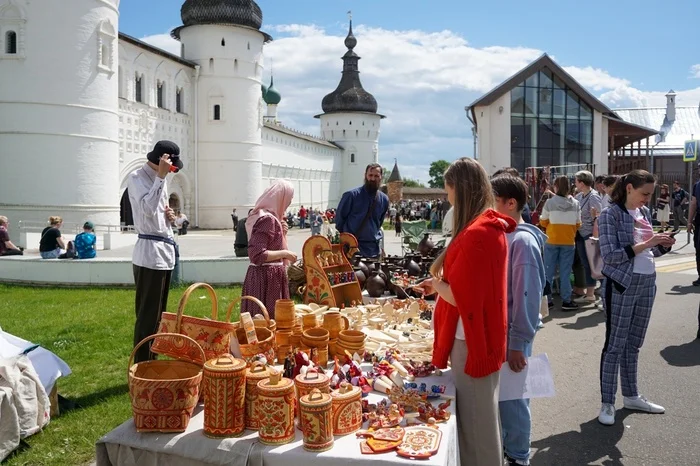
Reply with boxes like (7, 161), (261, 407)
(450, 340), (503, 466)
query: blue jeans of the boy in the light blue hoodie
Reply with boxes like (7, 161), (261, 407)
(498, 342), (532, 464)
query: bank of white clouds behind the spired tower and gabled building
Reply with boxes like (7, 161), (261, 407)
(142, 24), (700, 181)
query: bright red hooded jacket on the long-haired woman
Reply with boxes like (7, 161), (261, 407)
(433, 209), (516, 377)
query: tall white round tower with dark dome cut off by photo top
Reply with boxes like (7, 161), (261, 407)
(172, 0), (271, 228)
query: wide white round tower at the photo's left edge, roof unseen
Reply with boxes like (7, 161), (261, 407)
(0, 0), (119, 233)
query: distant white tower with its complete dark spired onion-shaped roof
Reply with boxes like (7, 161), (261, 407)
(316, 19), (384, 193)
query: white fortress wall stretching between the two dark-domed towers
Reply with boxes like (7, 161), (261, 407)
(262, 126), (343, 210)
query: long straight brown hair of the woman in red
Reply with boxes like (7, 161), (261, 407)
(430, 157), (494, 278)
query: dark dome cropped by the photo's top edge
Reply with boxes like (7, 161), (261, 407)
(172, 0), (270, 39)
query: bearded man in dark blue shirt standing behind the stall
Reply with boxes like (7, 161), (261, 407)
(335, 163), (389, 257)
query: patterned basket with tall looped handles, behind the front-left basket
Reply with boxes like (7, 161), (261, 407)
(151, 283), (237, 365)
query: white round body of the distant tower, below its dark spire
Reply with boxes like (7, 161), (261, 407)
(320, 113), (381, 193)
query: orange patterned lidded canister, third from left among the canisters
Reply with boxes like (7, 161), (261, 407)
(256, 370), (296, 445)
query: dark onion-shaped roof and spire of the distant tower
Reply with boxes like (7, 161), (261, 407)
(321, 21), (377, 113)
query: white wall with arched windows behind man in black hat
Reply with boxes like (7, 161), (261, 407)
(119, 41), (195, 219)
